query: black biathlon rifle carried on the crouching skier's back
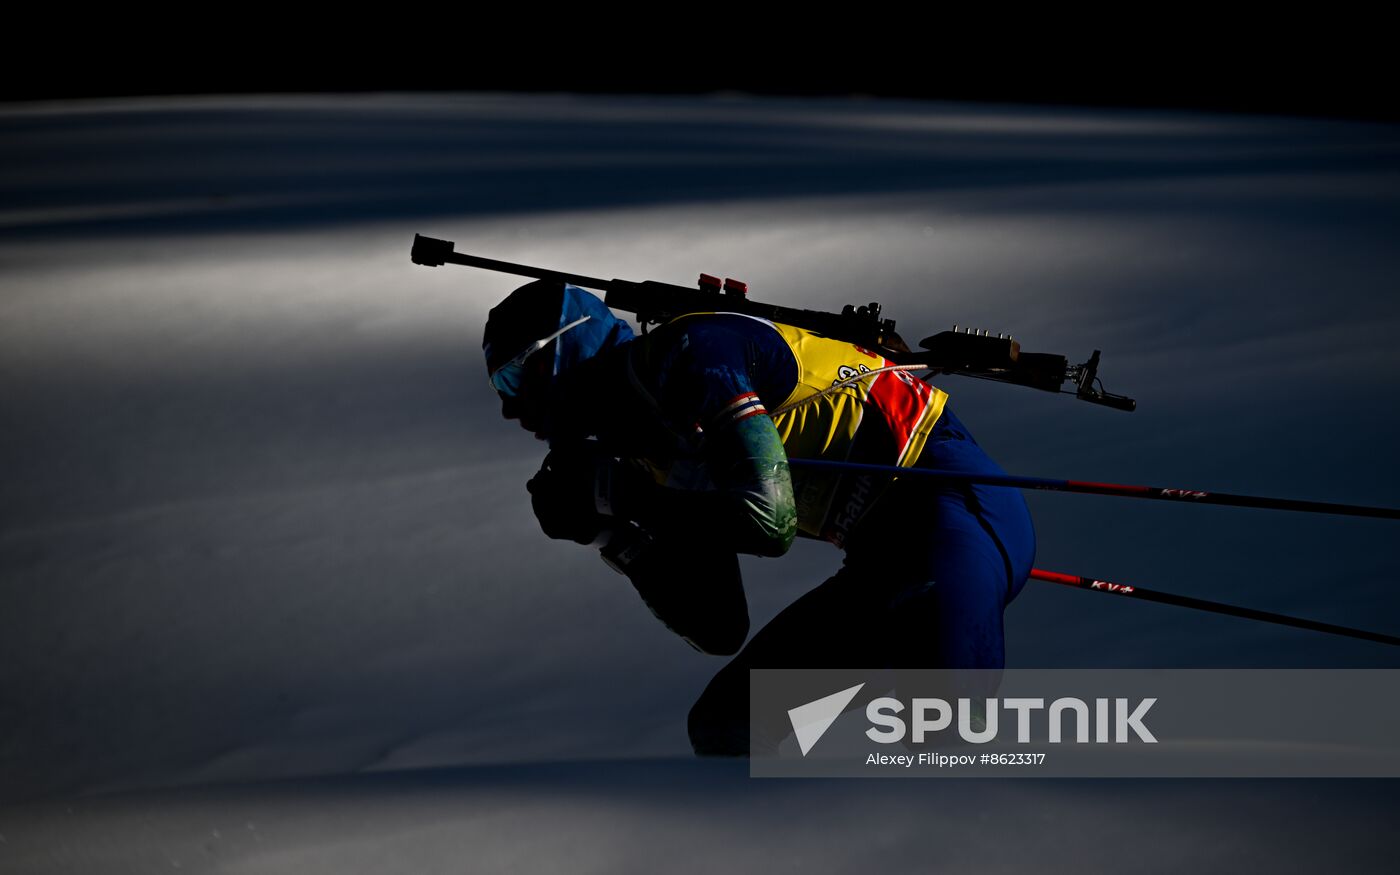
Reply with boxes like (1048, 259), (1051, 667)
(412, 234), (1137, 412)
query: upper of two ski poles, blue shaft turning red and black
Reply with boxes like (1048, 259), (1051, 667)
(788, 458), (1400, 519)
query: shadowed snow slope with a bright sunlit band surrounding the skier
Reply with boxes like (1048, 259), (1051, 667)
(0, 95), (1400, 872)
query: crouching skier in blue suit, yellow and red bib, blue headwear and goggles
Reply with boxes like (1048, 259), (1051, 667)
(483, 280), (1035, 755)
